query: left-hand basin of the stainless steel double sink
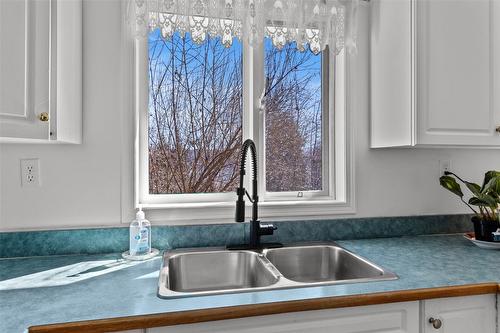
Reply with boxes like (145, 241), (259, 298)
(158, 251), (279, 296)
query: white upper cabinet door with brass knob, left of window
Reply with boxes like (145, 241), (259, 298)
(0, 0), (50, 139)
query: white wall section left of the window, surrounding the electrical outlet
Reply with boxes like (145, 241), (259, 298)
(0, 1), (121, 230)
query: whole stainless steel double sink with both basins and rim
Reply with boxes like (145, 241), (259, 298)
(158, 243), (397, 298)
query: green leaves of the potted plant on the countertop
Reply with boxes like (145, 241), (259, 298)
(439, 170), (500, 221)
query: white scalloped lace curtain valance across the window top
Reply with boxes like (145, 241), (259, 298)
(131, 0), (359, 54)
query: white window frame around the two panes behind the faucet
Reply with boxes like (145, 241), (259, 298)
(133, 29), (356, 224)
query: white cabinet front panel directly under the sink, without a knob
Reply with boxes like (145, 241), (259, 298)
(146, 302), (419, 333)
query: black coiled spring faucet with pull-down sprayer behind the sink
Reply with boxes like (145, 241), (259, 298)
(235, 139), (281, 249)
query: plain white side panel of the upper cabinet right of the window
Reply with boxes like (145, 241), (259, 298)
(370, 0), (414, 148)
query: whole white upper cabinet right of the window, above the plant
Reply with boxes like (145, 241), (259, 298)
(371, 0), (500, 147)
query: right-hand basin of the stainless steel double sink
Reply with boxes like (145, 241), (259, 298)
(265, 245), (392, 283)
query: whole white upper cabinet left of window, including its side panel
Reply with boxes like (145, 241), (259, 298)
(0, 0), (82, 143)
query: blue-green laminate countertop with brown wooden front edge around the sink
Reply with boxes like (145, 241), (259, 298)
(0, 235), (500, 333)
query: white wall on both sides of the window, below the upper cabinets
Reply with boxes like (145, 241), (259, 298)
(0, 0), (500, 230)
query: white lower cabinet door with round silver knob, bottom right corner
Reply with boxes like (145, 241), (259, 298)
(422, 295), (496, 333)
